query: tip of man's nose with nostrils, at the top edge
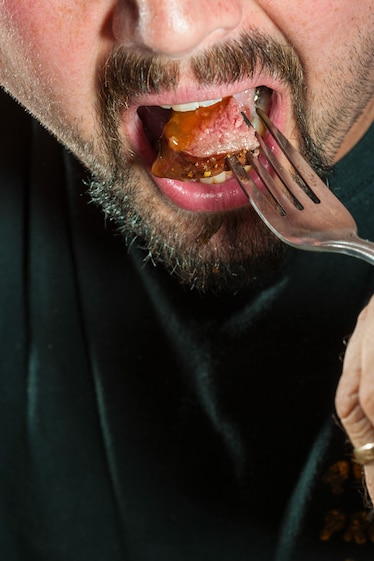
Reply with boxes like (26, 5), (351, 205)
(113, 0), (241, 58)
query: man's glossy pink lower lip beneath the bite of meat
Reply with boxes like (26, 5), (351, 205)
(152, 176), (248, 212)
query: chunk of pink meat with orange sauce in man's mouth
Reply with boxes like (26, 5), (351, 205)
(152, 97), (258, 181)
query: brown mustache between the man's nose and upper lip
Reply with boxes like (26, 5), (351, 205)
(99, 30), (304, 110)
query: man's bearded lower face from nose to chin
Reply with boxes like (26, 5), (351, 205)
(0, 0), (374, 290)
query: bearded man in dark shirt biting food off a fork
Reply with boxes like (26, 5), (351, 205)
(0, 0), (374, 561)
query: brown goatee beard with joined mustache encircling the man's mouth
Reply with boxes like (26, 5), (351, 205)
(89, 32), (328, 292)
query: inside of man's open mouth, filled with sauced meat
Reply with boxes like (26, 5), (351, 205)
(138, 86), (272, 184)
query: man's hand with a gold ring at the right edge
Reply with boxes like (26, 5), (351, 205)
(336, 296), (374, 501)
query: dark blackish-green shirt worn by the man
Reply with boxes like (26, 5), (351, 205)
(0, 89), (374, 561)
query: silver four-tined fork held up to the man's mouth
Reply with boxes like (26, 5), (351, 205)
(227, 108), (374, 265)
